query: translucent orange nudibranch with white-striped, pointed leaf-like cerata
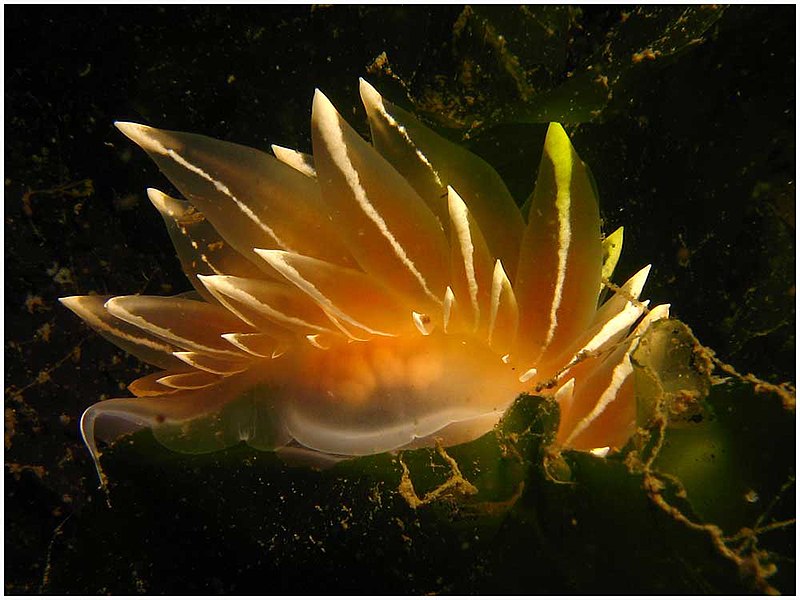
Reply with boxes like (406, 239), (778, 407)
(61, 80), (668, 478)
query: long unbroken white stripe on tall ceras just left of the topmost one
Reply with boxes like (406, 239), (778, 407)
(316, 90), (442, 306)
